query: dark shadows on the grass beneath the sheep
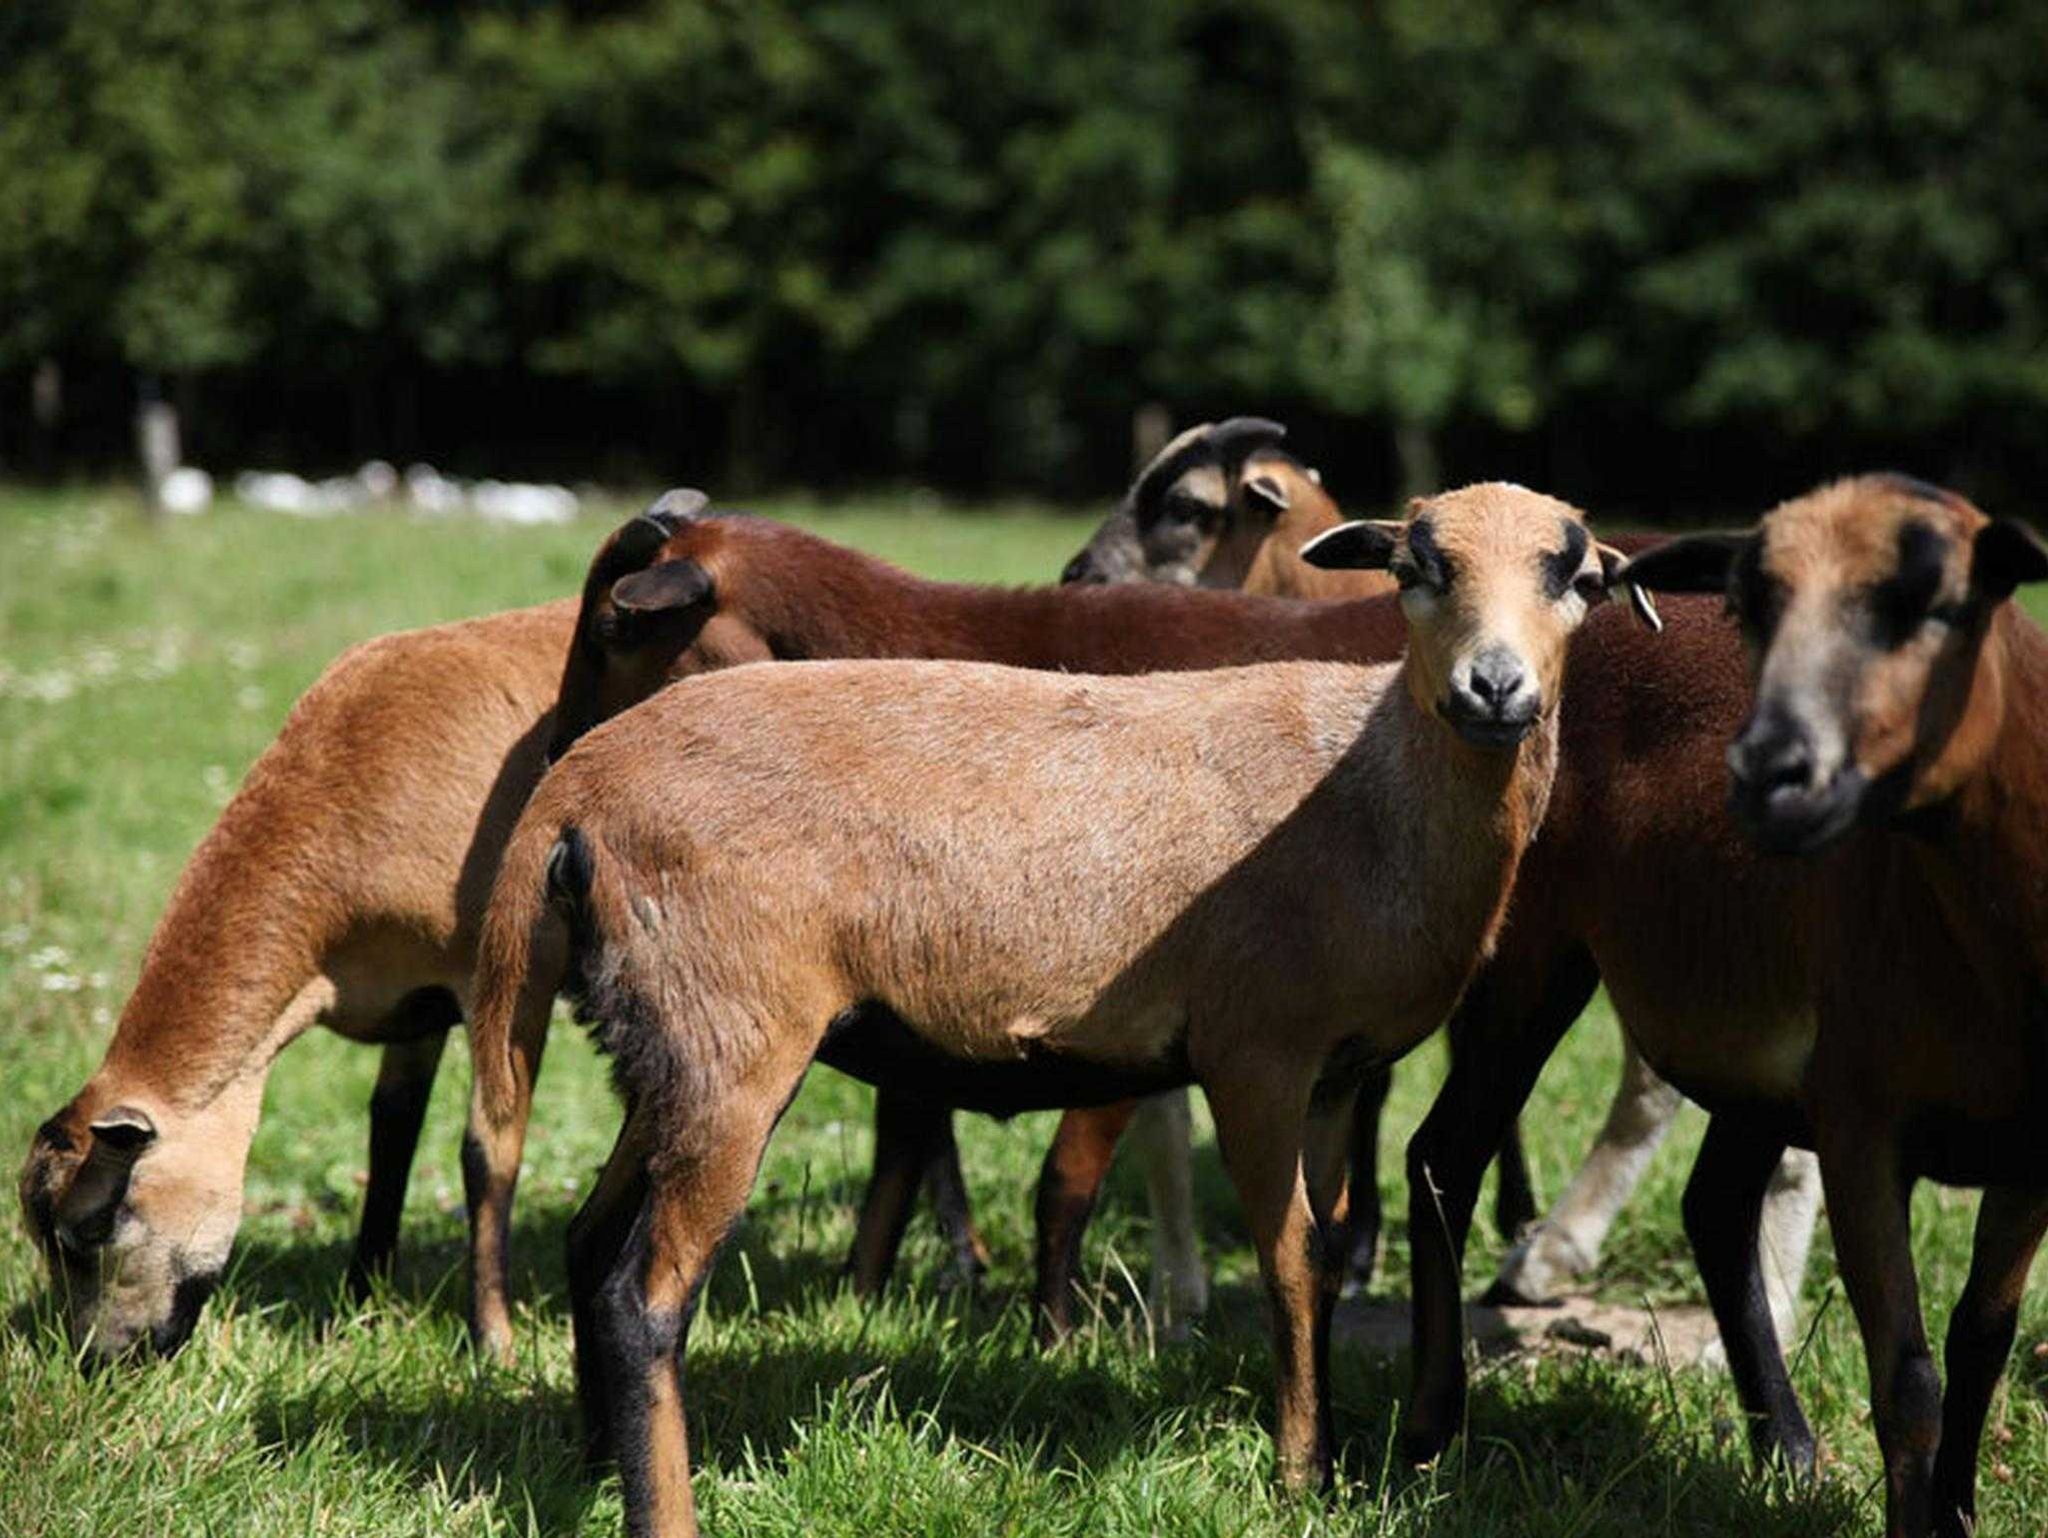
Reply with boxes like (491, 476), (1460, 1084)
(239, 1243), (1868, 1538)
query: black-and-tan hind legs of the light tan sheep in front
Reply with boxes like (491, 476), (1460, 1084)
(571, 1038), (815, 1538)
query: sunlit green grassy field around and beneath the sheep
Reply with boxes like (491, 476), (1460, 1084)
(0, 494), (2048, 1538)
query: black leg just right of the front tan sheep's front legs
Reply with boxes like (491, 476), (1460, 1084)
(1401, 948), (1599, 1462)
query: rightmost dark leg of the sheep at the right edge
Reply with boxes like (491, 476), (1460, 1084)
(1933, 1186), (2048, 1538)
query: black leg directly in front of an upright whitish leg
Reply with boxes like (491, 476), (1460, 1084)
(1683, 1114), (1812, 1475)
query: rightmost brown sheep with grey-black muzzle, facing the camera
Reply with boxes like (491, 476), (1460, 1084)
(1630, 475), (2048, 1538)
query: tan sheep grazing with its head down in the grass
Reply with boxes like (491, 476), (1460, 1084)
(20, 600), (575, 1362)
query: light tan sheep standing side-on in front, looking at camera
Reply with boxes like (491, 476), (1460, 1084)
(471, 485), (1646, 1534)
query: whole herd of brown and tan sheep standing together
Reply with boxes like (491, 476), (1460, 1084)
(20, 418), (2048, 1536)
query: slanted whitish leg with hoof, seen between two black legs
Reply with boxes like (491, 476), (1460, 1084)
(1487, 1030), (1686, 1302)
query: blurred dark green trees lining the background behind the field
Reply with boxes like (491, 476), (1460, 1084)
(0, 0), (2048, 516)
